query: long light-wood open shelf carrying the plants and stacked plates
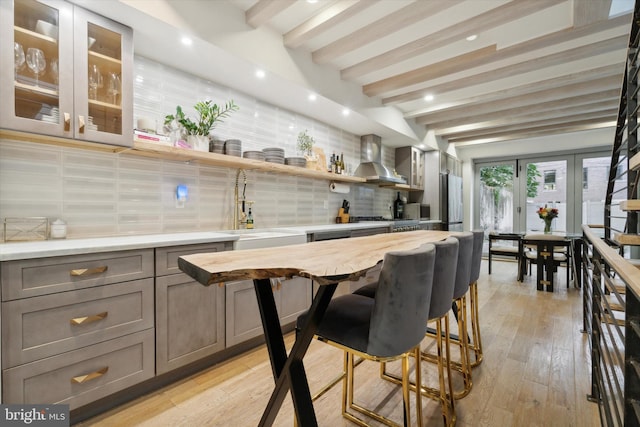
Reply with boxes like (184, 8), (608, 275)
(0, 129), (366, 184)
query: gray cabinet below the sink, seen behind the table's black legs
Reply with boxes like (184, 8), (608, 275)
(225, 277), (312, 347)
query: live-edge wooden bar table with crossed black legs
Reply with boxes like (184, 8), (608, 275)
(178, 230), (451, 427)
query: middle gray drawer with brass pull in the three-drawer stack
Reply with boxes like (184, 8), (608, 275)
(2, 279), (154, 367)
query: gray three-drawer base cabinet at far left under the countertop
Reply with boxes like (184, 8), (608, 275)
(0, 249), (155, 409)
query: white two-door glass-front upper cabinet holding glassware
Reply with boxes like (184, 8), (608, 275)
(0, 0), (133, 146)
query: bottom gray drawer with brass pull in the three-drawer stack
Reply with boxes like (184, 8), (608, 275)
(2, 329), (154, 409)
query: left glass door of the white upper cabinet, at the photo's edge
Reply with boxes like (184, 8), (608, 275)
(0, 0), (73, 136)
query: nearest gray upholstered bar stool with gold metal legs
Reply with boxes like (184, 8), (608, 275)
(297, 244), (436, 426)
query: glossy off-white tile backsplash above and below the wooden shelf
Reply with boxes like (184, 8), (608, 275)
(0, 57), (395, 238)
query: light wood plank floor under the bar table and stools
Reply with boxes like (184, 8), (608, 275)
(79, 261), (600, 427)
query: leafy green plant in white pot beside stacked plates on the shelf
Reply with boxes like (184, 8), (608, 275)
(164, 100), (239, 151)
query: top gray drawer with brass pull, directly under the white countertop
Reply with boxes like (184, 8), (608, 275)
(0, 249), (153, 301)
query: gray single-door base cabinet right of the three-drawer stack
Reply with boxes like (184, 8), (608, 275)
(156, 242), (232, 374)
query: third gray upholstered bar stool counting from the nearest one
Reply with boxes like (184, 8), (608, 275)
(422, 232), (473, 399)
